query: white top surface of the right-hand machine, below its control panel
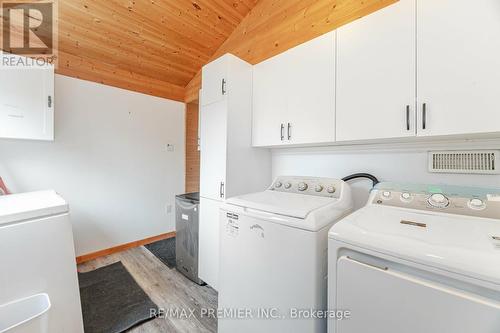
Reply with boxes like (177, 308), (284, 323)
(329, 206), (500, 285)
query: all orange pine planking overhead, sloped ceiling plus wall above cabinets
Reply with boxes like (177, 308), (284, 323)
(0, 0), (397, 102)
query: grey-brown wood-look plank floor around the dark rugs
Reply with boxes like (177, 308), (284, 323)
(78, 246), (217, 333)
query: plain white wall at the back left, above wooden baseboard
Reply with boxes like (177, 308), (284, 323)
(0, 75), (185, 255)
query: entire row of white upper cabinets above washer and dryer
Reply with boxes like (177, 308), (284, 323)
(253, 0), (500, 147)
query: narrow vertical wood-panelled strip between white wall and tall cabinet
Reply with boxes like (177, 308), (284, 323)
(186, 103), (200, 193)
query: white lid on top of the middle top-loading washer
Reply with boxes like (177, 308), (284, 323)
(226, 190), (338, 219)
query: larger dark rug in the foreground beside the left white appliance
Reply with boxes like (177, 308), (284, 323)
(78, 262), (158, 333)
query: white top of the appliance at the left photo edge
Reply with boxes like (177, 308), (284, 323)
(0, 191), (69, 226)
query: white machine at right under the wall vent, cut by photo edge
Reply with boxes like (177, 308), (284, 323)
(328, 183), (500, 333)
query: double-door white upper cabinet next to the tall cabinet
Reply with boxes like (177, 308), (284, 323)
(253, 32), (335, 146)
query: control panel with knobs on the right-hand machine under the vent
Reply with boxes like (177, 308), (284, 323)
(371, 183), (500, 219)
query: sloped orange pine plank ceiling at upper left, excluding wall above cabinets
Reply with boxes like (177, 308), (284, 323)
(57, 0), (257, 101)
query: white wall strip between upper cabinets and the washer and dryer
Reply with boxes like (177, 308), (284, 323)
(273, 141), (500, 208)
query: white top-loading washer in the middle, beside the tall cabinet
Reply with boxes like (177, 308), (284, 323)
(218, 177), (353, 333)
